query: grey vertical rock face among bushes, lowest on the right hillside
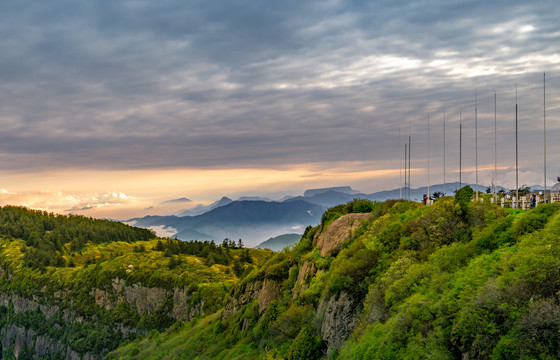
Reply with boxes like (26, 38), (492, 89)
(317, 292), (357, 353)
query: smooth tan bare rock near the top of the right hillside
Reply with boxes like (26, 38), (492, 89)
(313, 214), (372, 257)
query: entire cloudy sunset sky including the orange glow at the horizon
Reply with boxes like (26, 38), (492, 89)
(0, 0), (560, 219)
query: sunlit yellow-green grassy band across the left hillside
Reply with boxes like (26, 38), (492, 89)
(0, 239), (270, 295)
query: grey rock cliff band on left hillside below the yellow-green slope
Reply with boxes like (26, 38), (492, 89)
(90, 278), (204, 321)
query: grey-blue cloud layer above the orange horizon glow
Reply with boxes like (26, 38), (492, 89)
(0, 0), (560, 183)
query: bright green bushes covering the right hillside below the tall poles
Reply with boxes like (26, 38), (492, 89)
(340, 204), (560, 359)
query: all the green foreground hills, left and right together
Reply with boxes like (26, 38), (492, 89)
(0, 191), (560, 359)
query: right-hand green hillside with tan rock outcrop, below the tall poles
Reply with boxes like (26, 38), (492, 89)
(108, 187), (560, 359)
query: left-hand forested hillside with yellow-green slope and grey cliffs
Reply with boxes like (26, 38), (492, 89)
(0, 207), (272, 359)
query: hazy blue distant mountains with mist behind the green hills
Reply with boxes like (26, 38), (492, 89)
(126, 182), (500, 246)
